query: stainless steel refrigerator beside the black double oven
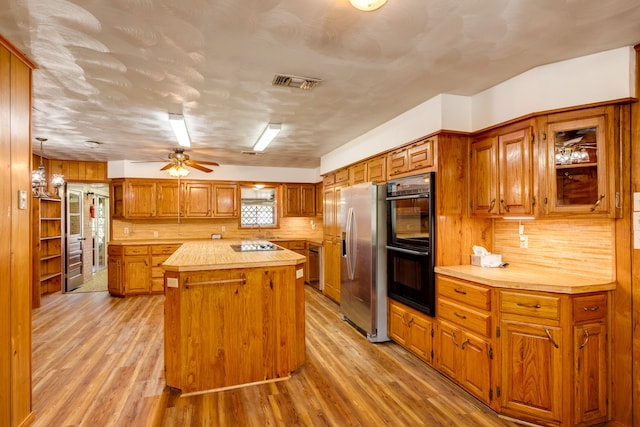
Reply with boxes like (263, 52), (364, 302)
(339, 182), (389, 342)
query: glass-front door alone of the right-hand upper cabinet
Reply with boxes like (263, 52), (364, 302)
(546, 113), (615, 214)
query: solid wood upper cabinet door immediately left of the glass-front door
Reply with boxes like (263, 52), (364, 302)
(498, 128), (533, 216)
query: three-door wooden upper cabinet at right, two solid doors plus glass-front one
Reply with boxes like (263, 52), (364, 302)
(469, 105), (622, 218)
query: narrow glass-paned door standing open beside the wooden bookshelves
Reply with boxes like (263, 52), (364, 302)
(65, 190), (84, 292)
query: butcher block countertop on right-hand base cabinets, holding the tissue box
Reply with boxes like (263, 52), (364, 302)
(435, 265), (616, 294)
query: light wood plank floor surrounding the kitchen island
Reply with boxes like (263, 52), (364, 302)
(33, 288), (514, 427)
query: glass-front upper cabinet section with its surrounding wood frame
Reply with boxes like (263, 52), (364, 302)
(541, 106), (620, 217)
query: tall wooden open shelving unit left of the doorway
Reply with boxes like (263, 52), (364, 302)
(32, 197), (64, 308)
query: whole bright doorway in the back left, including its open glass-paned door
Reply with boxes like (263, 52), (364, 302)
(64, 183), (109, 292)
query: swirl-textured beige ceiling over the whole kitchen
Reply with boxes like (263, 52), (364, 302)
(0, 0), (640, 167)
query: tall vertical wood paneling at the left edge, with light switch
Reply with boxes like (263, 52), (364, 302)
(0, 36), (35, 427)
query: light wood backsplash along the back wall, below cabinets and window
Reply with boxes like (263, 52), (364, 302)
(111, 217), (322, 241)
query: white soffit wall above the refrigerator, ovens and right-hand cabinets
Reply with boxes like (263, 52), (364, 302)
(320, 46), (635, 174)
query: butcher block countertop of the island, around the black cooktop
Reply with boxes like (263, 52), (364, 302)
(162, 240), (306, 271)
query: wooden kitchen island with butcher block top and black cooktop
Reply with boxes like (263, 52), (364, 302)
(162, 240), (305, 394)
